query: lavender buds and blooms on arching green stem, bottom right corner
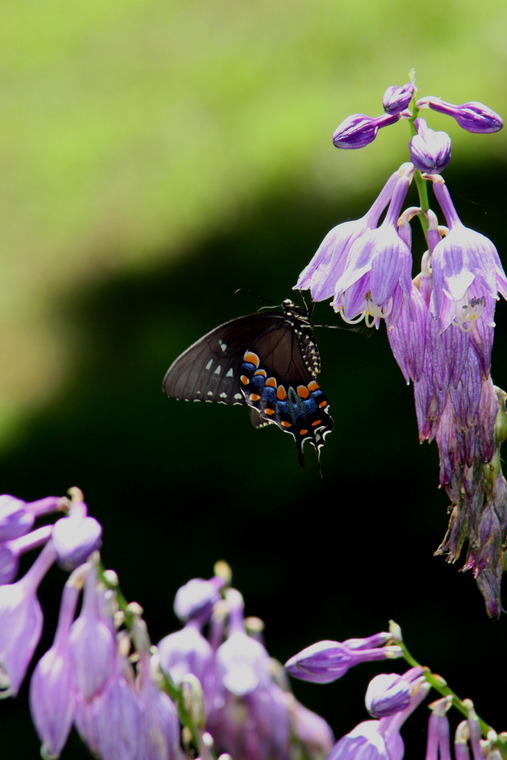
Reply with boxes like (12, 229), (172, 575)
(285, 623), (506, 760)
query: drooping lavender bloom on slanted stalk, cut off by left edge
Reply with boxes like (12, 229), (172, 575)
(0, 544), (56, 697)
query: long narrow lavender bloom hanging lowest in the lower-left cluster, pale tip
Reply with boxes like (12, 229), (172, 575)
(30, 569), (81, 757)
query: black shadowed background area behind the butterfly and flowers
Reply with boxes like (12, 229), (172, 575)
(0, 159), (507, 758)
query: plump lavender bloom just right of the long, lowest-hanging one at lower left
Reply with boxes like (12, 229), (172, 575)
(69, 563), (117, 700)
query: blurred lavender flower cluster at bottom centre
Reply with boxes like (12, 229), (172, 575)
(157, 576), (334, 760)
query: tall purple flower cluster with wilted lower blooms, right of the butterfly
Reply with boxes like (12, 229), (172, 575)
(295, 74), (507, 616)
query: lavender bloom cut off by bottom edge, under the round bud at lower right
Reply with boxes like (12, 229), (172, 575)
(327, 679), (430, 760)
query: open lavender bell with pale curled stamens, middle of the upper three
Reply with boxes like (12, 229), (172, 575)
(333, 164), (413, 327)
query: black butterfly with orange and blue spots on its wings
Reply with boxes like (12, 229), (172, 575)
(162, 299), (333, 464)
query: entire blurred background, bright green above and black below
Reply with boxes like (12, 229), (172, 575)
(0, 0), (507, 760)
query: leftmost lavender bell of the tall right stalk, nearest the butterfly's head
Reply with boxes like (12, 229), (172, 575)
(294, 172), (399, 301)
